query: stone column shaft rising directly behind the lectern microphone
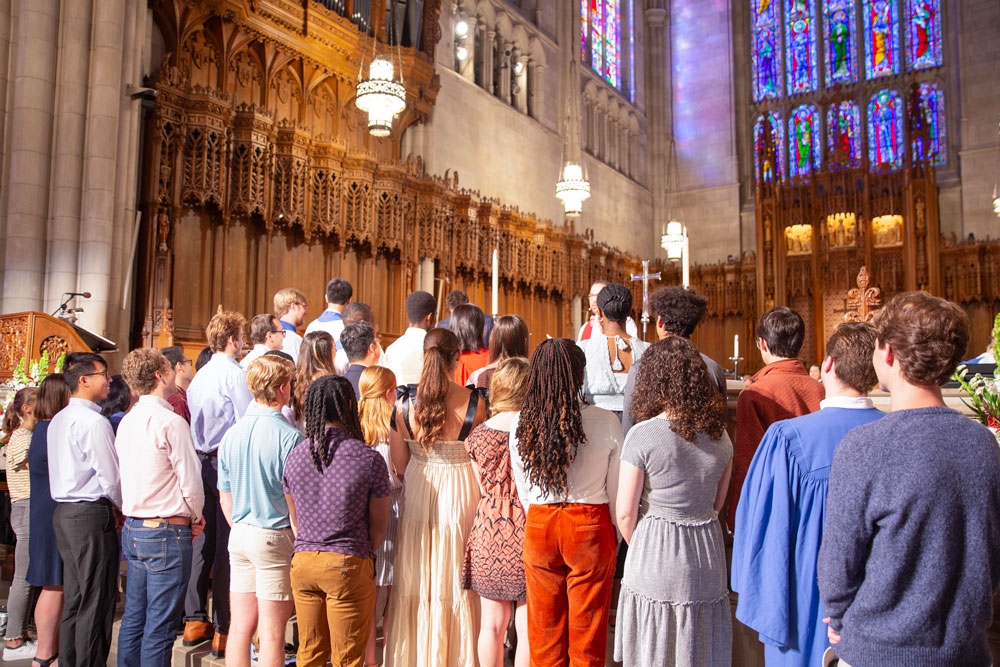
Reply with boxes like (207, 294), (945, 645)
(79, 0), (126, 333)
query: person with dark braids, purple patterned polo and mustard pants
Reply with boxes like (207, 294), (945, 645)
(282, 376), (389, 667)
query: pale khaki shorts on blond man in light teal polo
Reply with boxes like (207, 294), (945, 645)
(229, 523), (295, 601)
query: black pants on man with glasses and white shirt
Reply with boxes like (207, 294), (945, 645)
(52, 500), (121, 667)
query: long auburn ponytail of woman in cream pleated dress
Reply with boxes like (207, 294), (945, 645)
(413, 327), (459, 448)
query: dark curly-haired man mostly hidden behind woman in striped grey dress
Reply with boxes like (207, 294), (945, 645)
(622, 286), (726, 433)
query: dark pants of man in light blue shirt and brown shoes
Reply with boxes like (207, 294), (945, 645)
(188, 455), (229, 635)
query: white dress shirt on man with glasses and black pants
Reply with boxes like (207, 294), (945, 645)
(48, 398), (122, 507)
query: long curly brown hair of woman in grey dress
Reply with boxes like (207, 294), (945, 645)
(632, 336), (726, 442)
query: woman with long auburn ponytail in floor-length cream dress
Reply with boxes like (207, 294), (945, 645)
(385, 328), (486, 667)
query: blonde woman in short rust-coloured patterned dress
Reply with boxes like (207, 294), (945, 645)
(462, 357), (529, 667)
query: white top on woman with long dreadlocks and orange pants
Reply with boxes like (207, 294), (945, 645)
(510, 405), (625, 526)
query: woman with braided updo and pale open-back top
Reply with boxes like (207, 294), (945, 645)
(580, 283), (649, 419)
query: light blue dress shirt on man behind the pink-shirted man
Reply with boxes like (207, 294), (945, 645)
(188, 352), (253, 454)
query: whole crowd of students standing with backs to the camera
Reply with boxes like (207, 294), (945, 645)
(4, 278), (1000, 667)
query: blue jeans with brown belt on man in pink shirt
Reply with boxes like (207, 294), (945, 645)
(118, 517), (191, 667)
